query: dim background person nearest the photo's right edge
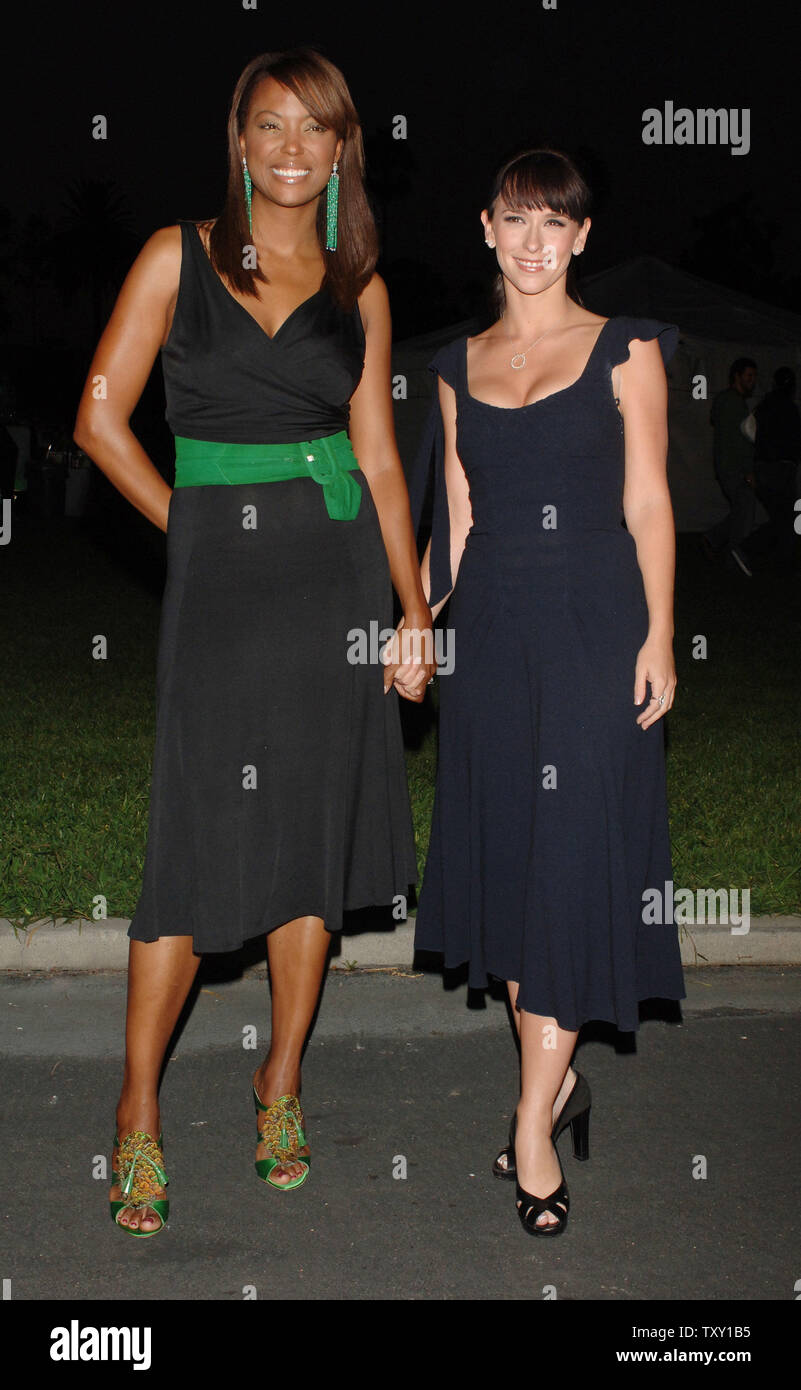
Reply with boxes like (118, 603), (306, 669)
(754, 367), (801, 574)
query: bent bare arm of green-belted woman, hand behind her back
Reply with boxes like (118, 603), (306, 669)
(74, 227), (181, 531)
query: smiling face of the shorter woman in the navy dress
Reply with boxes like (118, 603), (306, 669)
(481, 199), (590, 295)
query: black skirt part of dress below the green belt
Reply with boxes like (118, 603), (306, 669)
(128, 473), (417, 952)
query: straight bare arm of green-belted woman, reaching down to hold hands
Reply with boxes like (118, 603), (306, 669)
(349, 275), (435, 698)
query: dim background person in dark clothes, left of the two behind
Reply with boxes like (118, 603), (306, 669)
(702, 357), (757, 578)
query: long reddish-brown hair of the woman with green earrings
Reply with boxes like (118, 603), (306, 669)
(209, 47), (378, 310)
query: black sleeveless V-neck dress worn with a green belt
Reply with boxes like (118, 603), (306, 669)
(128, 222), (417, 952)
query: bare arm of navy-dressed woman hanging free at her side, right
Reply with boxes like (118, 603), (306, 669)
(620, 339), (676, 728)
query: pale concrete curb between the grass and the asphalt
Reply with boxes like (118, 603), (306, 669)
(0, 916), (801, 970)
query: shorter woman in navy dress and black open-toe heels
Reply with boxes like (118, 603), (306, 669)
(412, 150), (684, 1236)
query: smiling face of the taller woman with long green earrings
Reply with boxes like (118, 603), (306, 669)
(239, 76), (342, 207)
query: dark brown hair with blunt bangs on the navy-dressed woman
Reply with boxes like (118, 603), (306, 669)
(487, 149), (592, 314)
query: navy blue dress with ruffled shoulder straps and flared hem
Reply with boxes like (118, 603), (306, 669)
(410, 317), (684, 1030)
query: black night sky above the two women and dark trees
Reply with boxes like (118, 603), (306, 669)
(6, 0), (801, 319)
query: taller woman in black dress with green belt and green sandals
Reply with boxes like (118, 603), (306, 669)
(75, 50), (434, 1237)
